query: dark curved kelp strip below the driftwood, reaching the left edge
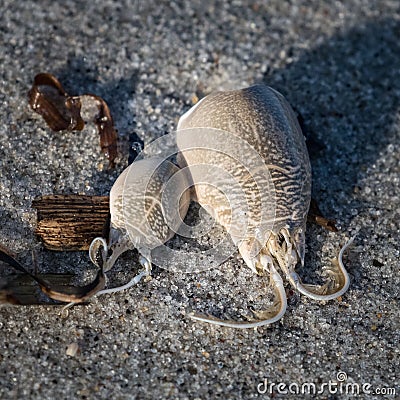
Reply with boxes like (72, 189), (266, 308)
(0, 247), (105, 303)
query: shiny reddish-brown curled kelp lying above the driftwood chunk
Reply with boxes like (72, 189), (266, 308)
(28, 73), (118, 167)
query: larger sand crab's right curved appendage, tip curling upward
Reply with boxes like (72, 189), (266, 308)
(288, 236), (355, 301)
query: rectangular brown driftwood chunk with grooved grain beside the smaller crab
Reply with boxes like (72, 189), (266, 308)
(32, 195), (109, 251)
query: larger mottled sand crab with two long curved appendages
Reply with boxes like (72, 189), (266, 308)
(177, 85), (350, 328)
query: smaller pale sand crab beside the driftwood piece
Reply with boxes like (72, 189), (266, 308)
(89, 157), (190, 288)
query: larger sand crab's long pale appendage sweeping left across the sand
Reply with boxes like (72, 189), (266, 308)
(189, 256), (287, 329)
